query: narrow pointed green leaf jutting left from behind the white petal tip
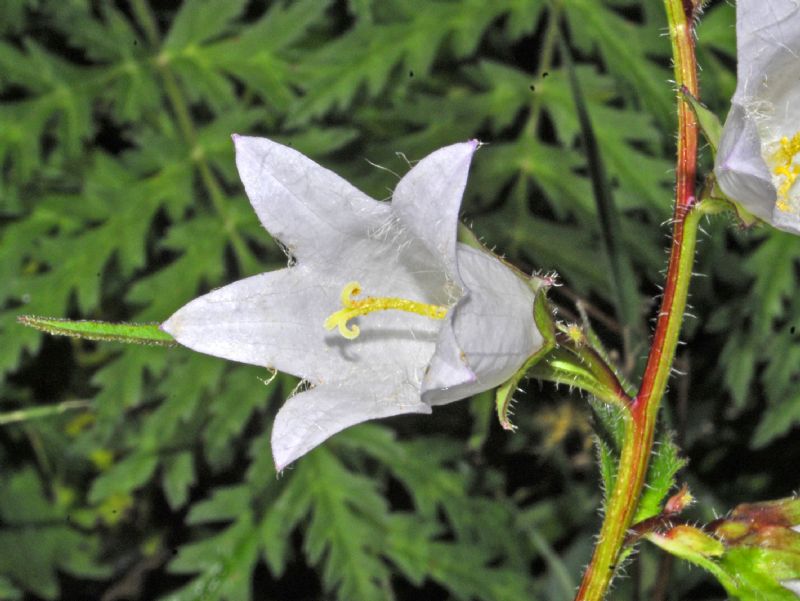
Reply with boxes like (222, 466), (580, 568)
(17, 315), (176, 346)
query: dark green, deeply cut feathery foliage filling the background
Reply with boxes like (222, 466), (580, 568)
(0, 0), (800, 601)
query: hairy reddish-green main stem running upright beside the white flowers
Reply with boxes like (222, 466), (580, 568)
(576, 0), (702, 601)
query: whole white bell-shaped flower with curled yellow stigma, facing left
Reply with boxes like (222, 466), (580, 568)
(162, 136), (543, 470)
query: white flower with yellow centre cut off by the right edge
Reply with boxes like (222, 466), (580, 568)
(714, 0), (800, 233)
